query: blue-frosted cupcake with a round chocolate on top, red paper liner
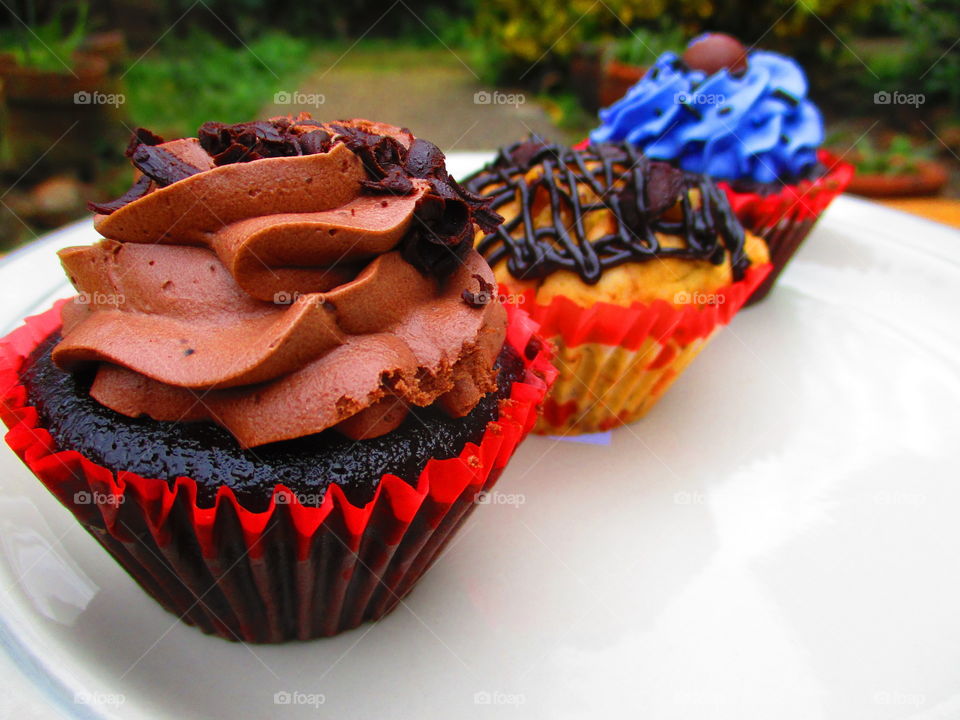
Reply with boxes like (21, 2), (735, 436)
(590, 33), (853, 301)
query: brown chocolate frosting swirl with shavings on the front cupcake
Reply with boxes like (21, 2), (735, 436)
(53, 116), (506, 447)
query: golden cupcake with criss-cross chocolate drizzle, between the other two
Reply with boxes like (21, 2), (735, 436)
(464, 139), (770, 434)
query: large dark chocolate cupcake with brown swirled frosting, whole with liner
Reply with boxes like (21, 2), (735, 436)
(0, 115), (553, 642)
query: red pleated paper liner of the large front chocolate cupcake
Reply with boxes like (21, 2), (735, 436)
(0, 304), (556, 643)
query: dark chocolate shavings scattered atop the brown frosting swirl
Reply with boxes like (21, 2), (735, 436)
(89, 116), (503, 278)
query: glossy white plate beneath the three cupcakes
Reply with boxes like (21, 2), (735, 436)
(0, 155), (960, 720)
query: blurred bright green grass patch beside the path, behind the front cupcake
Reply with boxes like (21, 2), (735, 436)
(124, 32), (314, 137)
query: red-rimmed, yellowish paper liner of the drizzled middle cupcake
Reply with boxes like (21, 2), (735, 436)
(523, 263), (771, 435)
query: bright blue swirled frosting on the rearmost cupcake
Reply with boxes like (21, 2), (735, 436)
(590, 36), (824, 183)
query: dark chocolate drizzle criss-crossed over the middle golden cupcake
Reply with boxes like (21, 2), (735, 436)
(464, 138), (750, 285)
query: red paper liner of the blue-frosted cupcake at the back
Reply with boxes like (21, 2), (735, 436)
(717, 150), (854, 305)
